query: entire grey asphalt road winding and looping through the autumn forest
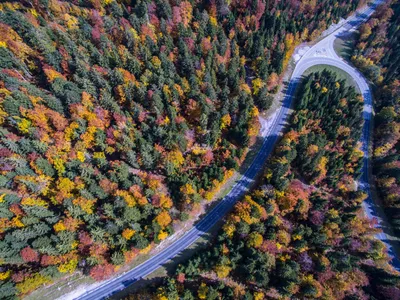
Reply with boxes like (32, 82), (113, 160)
(76, 1), (400, 300)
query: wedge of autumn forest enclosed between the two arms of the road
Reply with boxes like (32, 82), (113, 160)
(127, 71), (400, 300)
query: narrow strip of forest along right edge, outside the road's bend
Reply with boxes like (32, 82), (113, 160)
(352, 1), (400, 236)
